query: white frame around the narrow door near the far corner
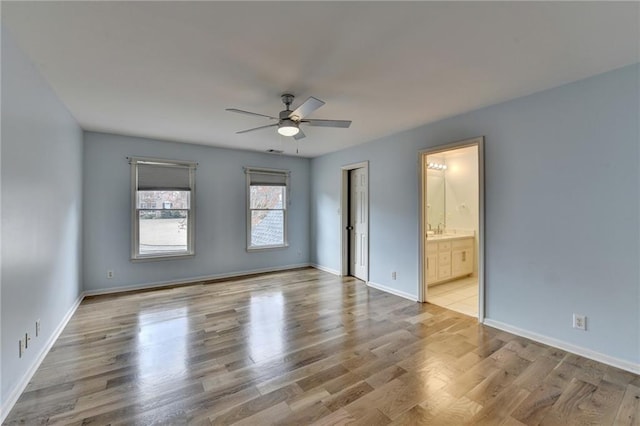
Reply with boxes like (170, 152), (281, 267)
(340, 161), (371, 283)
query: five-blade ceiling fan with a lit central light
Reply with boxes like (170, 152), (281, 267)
(226, 93), (351, 139)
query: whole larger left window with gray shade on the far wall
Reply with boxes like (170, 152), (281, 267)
(130, 158), (196, 260)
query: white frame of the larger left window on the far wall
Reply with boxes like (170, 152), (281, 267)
(128, 157), (198, 262)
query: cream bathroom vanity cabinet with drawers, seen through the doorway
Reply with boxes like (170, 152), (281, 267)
(426, 237), (474, 285)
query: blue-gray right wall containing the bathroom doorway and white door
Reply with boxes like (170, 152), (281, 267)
(311, 64), (640, 366)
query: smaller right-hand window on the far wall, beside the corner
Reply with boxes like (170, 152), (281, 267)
(245, 168), (289, 250)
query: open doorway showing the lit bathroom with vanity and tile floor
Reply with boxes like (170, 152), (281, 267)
(419, 137), (484, 321)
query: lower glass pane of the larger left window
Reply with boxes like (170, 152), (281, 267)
(139, 210), (189, 255)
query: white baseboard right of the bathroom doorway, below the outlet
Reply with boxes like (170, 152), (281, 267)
(484, 318), (640, 374)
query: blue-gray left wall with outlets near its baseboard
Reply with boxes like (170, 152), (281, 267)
(0, 28), (82, 408)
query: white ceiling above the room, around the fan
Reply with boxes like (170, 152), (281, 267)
(2, 1), (640, 157)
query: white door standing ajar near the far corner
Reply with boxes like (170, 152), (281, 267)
(348, 168), (369, 281)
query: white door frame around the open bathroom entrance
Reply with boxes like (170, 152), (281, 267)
(418, 136), (485, 323)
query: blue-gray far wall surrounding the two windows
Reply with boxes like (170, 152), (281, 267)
(84, 132), (310, 291)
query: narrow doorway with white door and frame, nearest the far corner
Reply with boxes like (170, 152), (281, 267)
(340, 162), (369, 282)
